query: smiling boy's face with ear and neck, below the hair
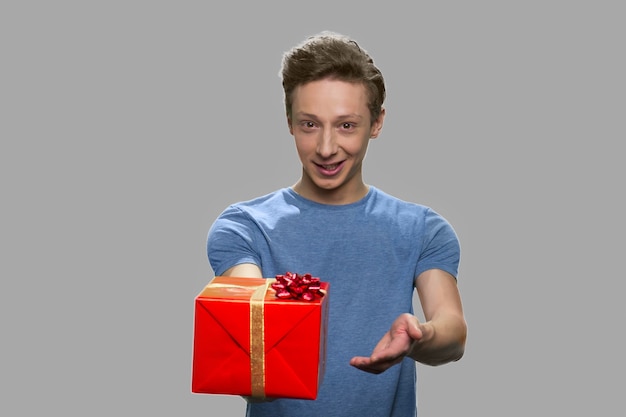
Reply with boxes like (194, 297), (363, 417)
(288, 79), (384, 204)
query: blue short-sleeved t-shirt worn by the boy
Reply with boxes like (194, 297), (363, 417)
(207, 186), (460, 417)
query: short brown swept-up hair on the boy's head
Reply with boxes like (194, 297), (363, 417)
(280, 31), (386, 123)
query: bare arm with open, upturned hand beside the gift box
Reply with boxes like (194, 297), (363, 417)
(350, 269), (467, 374)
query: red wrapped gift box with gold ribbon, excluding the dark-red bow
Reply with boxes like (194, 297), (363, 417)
(191, 277), (329, 399)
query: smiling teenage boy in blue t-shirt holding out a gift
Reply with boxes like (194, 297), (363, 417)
(207, 32), (467, 417)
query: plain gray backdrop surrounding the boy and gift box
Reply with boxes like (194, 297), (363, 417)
(0, 0), (626, 417)
